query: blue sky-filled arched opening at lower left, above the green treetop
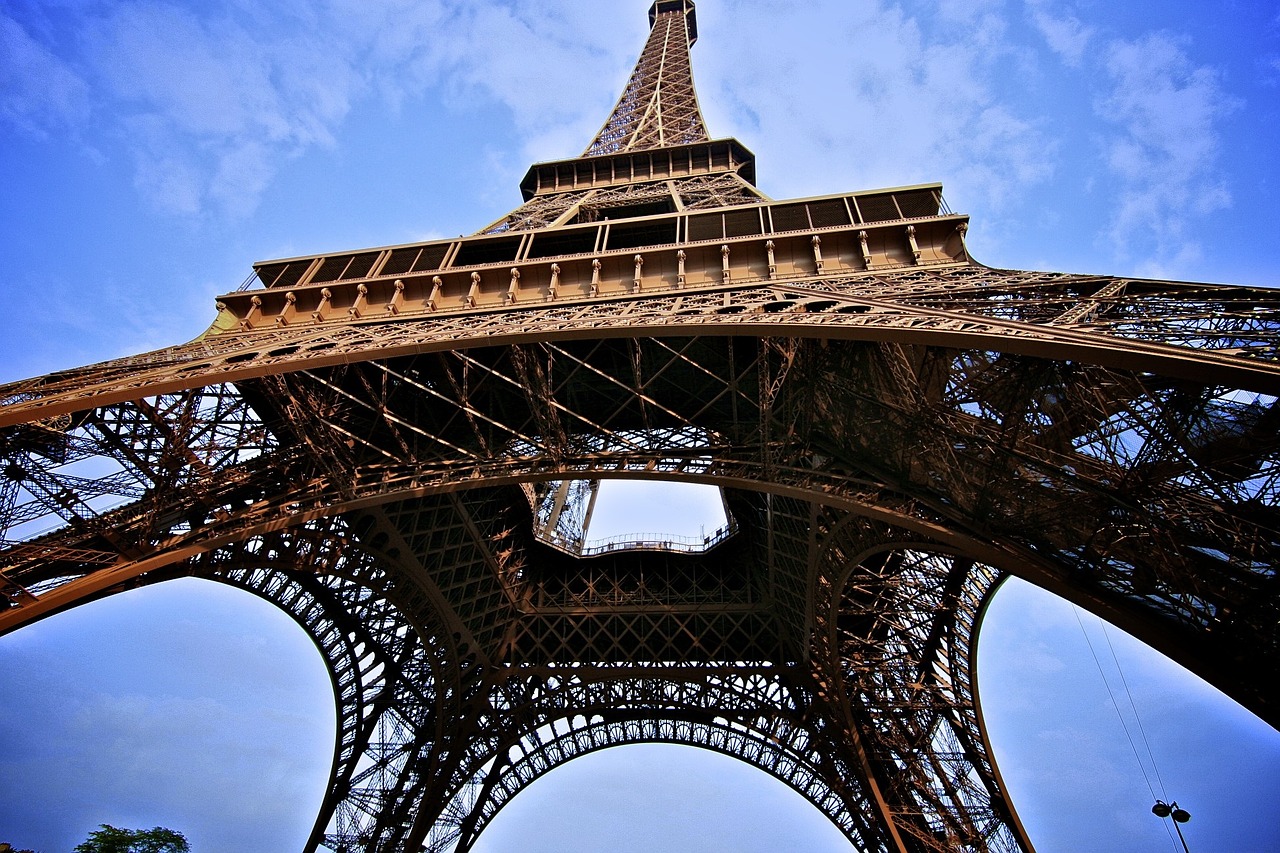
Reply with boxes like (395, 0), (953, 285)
(0, 579), (335, 853)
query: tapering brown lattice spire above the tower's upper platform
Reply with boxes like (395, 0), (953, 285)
(584, 0), (709, 156)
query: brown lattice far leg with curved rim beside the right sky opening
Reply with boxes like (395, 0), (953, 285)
(814, 528), (1033, 850)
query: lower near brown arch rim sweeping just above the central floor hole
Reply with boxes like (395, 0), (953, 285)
(0, 440), (1274, 719)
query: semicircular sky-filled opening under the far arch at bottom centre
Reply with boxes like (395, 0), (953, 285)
(472, 744), (850, 853)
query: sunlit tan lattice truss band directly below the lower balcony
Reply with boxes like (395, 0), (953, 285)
(0, 264), (1280, 414)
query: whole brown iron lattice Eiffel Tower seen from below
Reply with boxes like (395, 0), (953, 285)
(0, 0), (1280, 853)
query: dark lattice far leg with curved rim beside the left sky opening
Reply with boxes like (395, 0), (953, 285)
(188, 525), (466, 850)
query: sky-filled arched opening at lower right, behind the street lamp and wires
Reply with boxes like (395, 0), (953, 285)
(978, 579), (1280, 853)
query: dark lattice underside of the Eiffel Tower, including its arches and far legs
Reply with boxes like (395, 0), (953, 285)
(0, 283), (1280, 852)
